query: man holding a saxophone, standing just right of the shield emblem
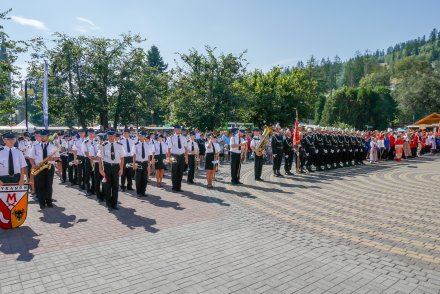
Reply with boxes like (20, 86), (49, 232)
(30, 130), (60, 209)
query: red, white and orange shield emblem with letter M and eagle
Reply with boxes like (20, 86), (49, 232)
(0, 186), (28, 229)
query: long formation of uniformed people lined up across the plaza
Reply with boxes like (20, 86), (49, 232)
(0, 124), (440, 210)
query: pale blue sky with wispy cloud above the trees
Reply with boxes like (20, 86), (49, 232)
(0, 0), (440, 70)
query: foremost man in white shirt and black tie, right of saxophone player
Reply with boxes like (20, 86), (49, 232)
(98, 130), (126, 210)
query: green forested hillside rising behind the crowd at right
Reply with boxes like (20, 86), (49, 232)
(286, 29), (440, 128)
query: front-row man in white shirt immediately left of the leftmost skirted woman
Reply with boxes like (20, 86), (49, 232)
(132, 131), (153, 197)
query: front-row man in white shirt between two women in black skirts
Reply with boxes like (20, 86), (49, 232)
(167, 125), (188, 192)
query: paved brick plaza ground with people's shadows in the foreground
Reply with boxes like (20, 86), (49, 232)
(0, 157), (440, 293)
